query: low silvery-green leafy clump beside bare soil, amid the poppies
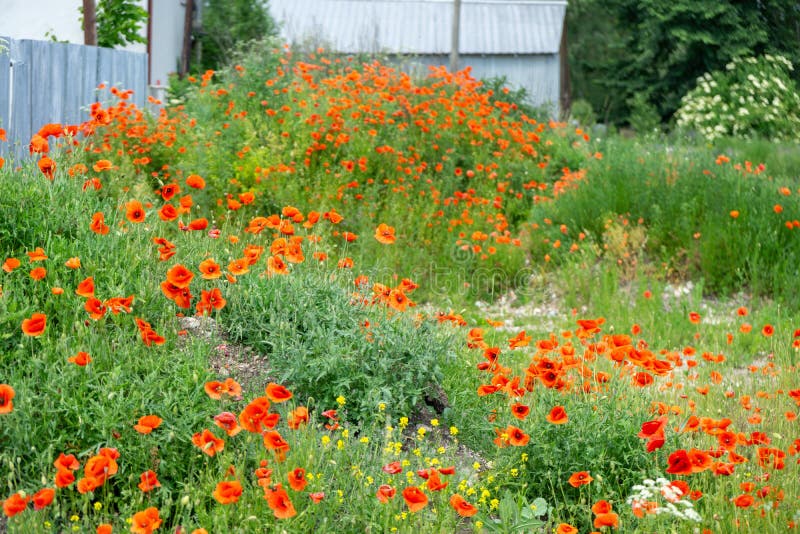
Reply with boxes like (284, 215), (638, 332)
(224, 271), (454, 421)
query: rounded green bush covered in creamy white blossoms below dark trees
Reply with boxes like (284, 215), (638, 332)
(676, 54), (800, 141)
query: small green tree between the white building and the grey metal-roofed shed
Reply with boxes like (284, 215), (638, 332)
(195, 0), (278, 70)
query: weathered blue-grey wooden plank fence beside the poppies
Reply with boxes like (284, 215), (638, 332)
(0, 36), (147, 159)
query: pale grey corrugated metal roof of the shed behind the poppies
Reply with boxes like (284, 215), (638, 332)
(269, 0), (567, 54)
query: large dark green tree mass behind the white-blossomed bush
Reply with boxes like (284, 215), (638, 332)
(567, 0), (800, 123)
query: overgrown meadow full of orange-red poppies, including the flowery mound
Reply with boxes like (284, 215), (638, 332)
(0, 44), (800, 534)
